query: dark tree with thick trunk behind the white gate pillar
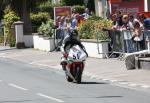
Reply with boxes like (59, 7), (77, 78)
(0, 0), (47, 33)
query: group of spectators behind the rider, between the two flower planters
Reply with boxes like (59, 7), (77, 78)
(56, 8), (90, 39)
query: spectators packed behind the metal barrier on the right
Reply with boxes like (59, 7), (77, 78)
(111, 10), (150, 50)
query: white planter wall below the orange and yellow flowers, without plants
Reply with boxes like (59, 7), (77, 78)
(81, 39), (109, 58)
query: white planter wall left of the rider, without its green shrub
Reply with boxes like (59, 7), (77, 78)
(33, 34), (55, 51)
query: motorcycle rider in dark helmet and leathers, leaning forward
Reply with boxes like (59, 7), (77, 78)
(60, 29), (88, 70)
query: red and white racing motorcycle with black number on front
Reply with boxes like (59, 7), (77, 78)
(62, 45), (87, 83)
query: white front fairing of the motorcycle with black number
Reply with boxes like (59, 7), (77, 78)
(68, 45), (87, 62)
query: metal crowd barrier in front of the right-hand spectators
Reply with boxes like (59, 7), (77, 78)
(109, 30), (146, 58)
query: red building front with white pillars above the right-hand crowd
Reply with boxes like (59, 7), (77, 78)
(95, 0), (150, 18)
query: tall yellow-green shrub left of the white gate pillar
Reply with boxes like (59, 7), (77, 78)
(4, 8), (20, 46)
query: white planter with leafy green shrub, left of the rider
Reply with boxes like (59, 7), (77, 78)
(33, 19), (55, 51)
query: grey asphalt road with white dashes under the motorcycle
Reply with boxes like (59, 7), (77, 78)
(0, 58), (150, 103)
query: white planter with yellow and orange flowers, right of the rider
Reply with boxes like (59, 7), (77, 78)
(78, 18), (111, 58)
